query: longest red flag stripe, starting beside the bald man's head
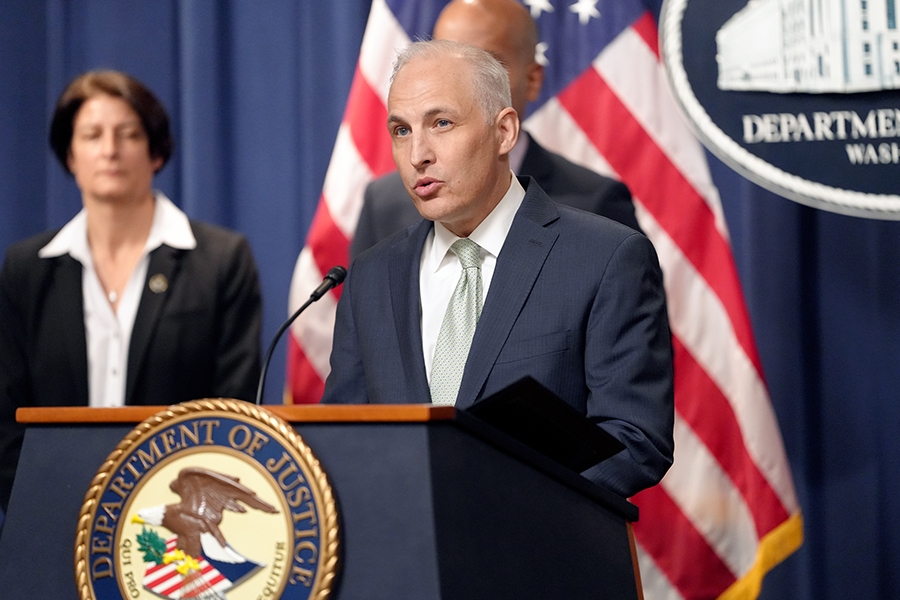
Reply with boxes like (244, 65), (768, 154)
(559, 69), (762, 378)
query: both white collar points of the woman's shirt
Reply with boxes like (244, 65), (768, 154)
(38, 192), (197, 264)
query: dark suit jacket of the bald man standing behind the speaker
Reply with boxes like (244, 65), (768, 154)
(350, 132), (641, 257)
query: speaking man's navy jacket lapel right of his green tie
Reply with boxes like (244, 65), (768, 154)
(456, 180), (559, 408)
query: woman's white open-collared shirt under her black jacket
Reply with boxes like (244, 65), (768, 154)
(38, 192), (197, 406)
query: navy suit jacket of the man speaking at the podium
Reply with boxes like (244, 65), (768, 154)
(322, 178), (674, 497)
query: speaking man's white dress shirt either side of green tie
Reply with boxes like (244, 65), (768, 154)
(419, 175), (525, 381)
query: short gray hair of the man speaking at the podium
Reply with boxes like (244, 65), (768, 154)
(391, 40), (512, 125)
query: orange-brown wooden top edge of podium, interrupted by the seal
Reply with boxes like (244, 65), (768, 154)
(16, 404), (456, 424)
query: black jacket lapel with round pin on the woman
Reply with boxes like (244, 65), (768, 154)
(125, 245), (184, 404)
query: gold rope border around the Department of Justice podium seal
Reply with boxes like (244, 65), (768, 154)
(75, 398), (339, 600)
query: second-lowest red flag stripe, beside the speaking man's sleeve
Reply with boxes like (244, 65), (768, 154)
(672, 336), (789, 538)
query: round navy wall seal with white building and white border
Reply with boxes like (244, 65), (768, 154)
(659, 0), (900, 220)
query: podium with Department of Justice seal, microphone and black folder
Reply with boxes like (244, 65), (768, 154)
(0, 267), (642, 600)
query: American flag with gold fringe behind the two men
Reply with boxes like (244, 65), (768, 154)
(287, 0), (803, 600)
